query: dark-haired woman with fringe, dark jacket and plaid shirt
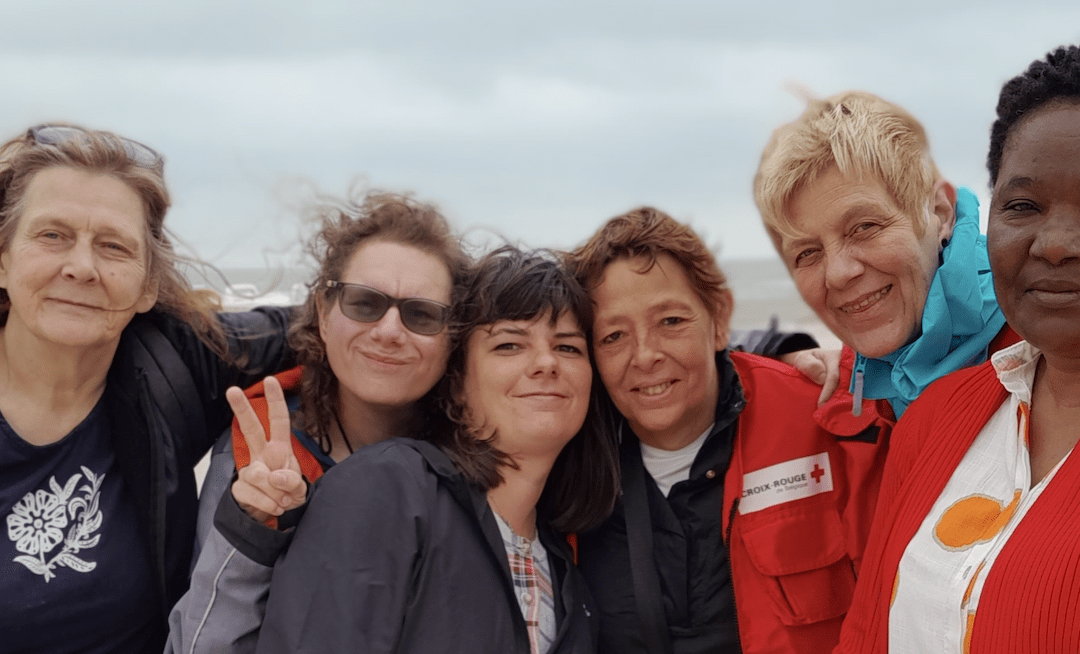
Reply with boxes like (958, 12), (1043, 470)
(251, 248), (618, 654)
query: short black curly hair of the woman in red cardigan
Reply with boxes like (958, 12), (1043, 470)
(986, 45), (1080, 189)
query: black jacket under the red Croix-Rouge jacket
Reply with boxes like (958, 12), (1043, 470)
(578, 354), (745, 654)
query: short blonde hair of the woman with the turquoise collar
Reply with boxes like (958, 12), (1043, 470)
(754, 91), (941, 250)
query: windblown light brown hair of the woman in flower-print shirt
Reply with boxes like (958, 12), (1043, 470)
(0, 123), (225, 360)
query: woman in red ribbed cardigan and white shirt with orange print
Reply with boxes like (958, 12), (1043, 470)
(837, 46), (1080, 654)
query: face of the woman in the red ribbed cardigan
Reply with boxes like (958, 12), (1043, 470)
(986, 103), (1080, 358)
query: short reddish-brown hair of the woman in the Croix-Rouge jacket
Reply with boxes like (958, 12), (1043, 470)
(569, 206), (732, 321)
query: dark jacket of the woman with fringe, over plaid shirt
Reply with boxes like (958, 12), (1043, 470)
(258, 438), (596, 654)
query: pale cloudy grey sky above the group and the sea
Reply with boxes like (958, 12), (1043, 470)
(0, 0), (1080, 271)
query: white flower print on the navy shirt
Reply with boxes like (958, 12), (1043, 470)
(8, 466), (105, 583)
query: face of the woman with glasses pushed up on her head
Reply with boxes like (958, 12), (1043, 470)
(0, 166), (157, 356)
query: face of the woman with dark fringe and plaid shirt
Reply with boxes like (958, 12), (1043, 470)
(462, 312), (593, 458)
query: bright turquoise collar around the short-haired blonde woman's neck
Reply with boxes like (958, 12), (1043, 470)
(851, 188), (1005, 419)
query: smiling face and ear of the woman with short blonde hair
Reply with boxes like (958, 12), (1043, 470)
(780, 167), (955, 357)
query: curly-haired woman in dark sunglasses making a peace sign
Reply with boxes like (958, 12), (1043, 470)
(166, 194), (468, 653)
